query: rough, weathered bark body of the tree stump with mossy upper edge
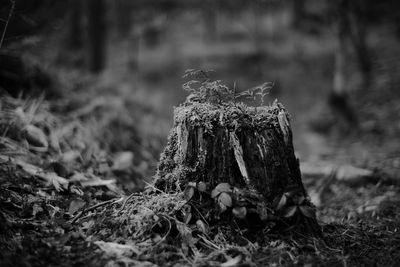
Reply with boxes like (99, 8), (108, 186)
(155, 102), (319, 232)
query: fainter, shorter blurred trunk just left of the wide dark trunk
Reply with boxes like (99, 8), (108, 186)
(68, 0), (83, 50)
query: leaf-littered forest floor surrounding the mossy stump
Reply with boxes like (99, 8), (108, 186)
(0, 8), (400, 267)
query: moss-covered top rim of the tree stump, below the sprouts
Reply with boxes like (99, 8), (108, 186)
(174, 101), (286, 128)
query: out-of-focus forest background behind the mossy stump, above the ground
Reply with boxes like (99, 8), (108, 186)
(0, 0), (400, 185)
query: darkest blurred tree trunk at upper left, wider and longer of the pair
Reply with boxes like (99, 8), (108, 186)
(86, 0), (106, 73)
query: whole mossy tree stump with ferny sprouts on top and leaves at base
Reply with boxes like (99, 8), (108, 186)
(154, 70), (320, 241)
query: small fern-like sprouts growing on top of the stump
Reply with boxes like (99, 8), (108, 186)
(182, 69), (274, 106)
